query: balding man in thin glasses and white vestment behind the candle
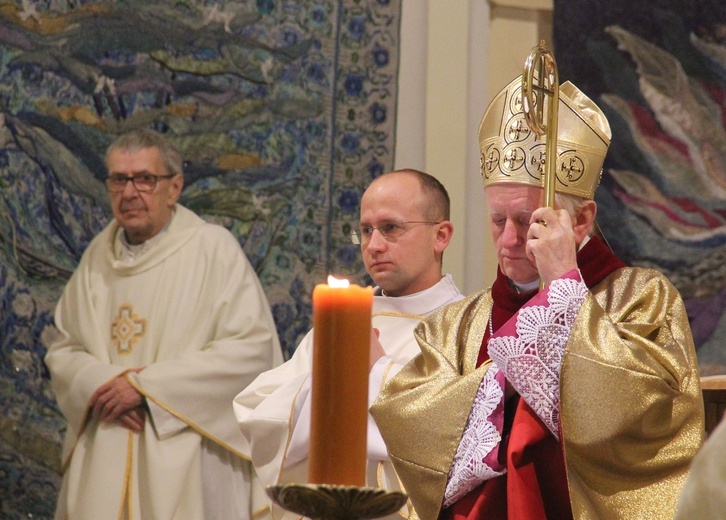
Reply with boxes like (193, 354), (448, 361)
(234, 170), (463, 519)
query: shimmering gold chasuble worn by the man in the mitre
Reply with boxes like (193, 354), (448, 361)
(371, 264), (704, 520)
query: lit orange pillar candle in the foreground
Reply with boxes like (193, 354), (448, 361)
(308, 276), (373, 487)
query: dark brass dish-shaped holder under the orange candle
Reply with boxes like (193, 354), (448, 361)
(266, 484), (408, 520)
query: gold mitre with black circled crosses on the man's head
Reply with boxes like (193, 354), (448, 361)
(479, 76), (612, 199)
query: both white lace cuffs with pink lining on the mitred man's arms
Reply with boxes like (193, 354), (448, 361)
(444, 270), (588, 507)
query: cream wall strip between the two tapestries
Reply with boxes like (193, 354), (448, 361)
(394, 0), (552, 293)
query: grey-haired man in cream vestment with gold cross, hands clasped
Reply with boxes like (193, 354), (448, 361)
(46, 127), (282, 520)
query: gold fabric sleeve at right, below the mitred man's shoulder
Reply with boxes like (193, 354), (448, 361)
(560, 269), (704, 519)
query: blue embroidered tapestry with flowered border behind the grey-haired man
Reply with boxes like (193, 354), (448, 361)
(0, 0), (400, 518)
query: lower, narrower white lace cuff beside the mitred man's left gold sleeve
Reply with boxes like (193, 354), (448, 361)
(444, 366), (506, 507)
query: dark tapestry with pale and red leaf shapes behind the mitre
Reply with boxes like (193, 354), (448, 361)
(554, 0), (726, 375)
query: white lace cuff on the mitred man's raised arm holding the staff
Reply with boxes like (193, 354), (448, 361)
(488, 277), (588, 440)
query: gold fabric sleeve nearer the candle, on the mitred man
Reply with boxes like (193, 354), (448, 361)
(371, 293), (492, 520)
